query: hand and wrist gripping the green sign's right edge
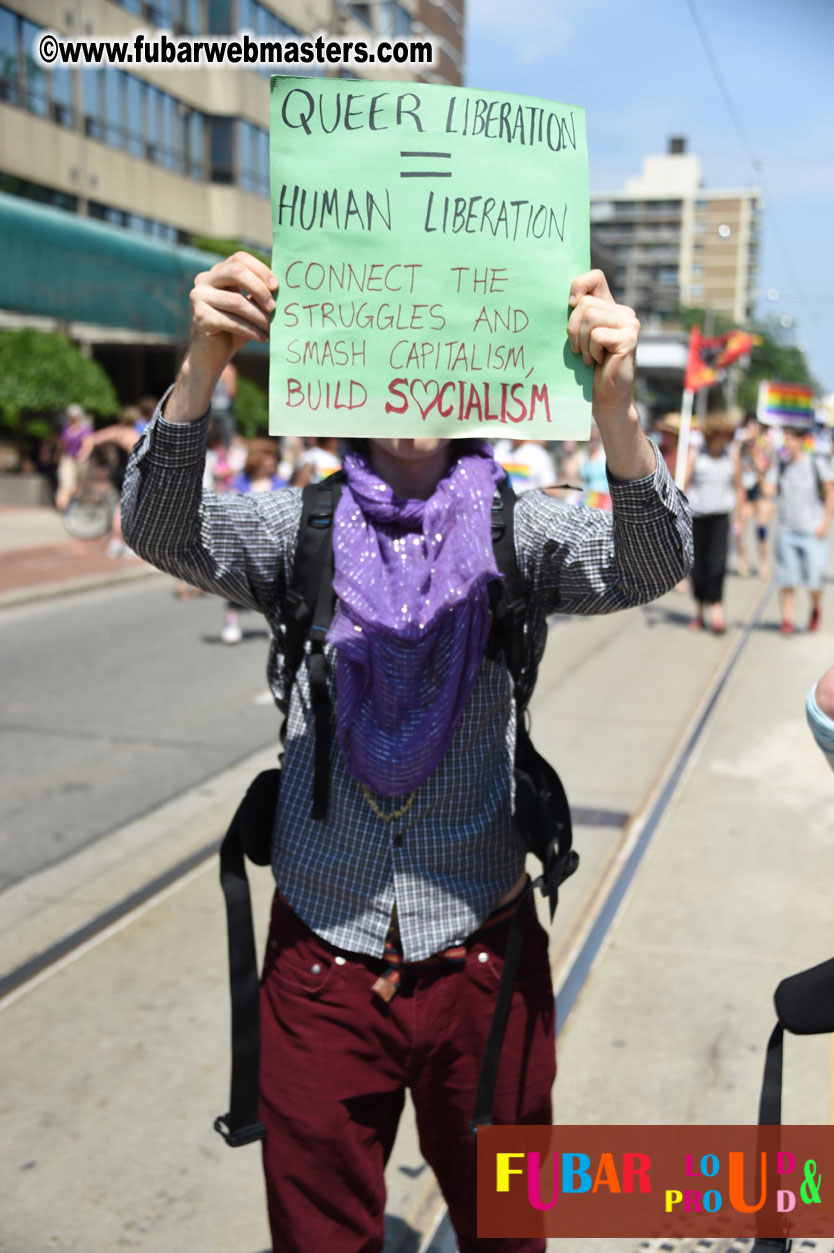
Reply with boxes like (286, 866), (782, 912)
(567, 269), (640, 426)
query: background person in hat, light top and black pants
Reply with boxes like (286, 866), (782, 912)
(684, 413), (741, 635)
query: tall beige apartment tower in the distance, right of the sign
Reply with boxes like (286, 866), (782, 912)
(591, 138), (761, 325)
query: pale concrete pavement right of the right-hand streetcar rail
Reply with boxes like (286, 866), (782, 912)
(548, 573), (834, 1253)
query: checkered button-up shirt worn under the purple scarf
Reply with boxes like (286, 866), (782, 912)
(121, 400), (691, 961)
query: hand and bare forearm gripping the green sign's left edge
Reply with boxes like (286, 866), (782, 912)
(165, 252), (278, 422)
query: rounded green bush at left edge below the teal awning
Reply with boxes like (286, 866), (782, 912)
(0, 330), (119, 442)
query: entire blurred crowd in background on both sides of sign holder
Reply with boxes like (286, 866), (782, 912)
(46, 395), (834, 644)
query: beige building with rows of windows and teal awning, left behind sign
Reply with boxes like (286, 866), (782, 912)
(0, 0), (463, 397)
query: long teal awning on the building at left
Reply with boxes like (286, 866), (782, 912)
(0, 193), (256, 341)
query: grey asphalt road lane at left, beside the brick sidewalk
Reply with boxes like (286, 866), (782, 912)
(0, 576), (279, 888)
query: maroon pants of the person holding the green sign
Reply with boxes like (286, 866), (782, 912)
(260, 898), (548, 1253)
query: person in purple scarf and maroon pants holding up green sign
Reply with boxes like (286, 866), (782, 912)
(117, 252), (691, 1253)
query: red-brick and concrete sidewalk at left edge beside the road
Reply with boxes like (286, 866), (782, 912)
(0, 506), (158, 608)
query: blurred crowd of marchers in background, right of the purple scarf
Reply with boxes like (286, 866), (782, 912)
(496, 412), (834, 635)
